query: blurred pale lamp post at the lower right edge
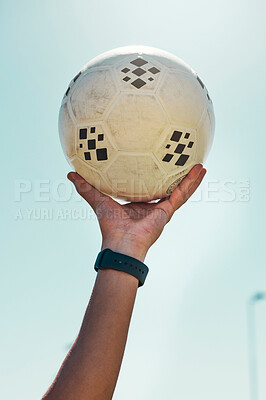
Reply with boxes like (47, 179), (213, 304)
(247, 292), (266, 400)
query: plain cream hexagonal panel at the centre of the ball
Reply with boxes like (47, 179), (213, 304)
(106, 93), (168, 152)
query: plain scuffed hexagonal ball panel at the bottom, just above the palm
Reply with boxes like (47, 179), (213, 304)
(105, 152), (165, 201)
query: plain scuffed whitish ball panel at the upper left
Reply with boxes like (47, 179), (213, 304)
(70, 69), (118, 123)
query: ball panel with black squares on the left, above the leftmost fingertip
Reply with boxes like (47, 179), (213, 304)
(76, 123), (116, 170)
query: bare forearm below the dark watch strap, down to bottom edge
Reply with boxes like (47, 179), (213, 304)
(43, 270), (138, 400)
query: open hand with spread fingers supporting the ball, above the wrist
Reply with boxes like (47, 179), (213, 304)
(68, 165), (206, 256)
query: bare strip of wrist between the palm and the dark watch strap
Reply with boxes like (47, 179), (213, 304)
(101, 237), (148, 262)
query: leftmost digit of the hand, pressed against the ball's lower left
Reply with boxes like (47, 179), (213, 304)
(67, 172), (113, 213)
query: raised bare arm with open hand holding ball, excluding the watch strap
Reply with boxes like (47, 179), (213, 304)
(43, 165), (206, 400)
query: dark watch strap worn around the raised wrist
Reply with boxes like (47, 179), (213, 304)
(94, 249), (149, 287)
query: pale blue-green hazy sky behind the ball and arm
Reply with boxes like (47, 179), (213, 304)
(0, 0), (266, 400)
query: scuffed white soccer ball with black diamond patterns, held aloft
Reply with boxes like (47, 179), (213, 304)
(59, 46), (214, 201)
